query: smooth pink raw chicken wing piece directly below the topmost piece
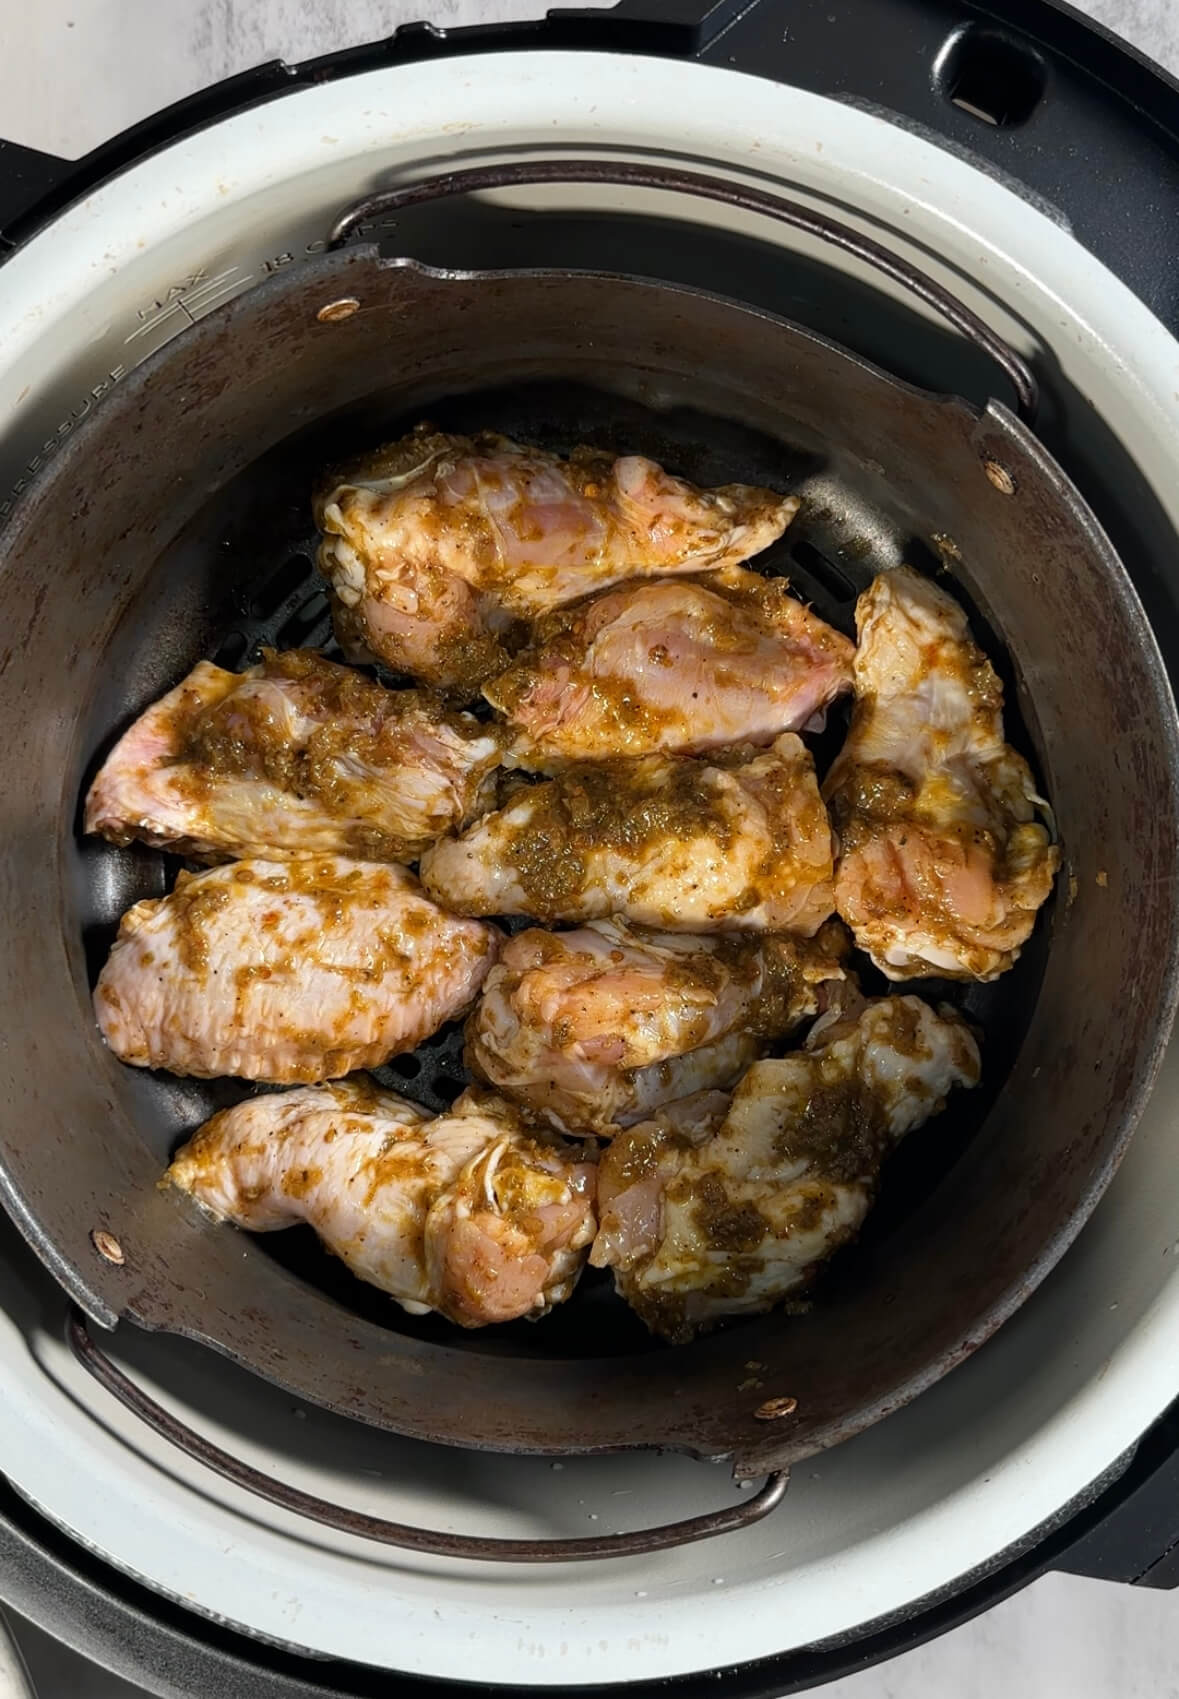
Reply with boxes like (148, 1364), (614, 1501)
(482, 566), (855, 770)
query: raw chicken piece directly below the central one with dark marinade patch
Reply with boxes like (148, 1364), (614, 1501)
(467, 919), (846, 1135)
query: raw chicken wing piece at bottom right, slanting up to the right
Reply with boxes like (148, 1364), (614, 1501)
(590, 997), (979, 1342)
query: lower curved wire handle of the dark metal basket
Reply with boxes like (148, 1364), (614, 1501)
(66, 1307), (790, 1563)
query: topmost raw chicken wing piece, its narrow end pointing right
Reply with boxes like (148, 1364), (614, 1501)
(314, 426), (798, 691)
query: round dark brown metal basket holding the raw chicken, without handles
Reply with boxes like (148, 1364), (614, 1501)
(0, 251), (1176, 1473)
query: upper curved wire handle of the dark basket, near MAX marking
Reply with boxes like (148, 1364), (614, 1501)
(328, 160), (1040, 423)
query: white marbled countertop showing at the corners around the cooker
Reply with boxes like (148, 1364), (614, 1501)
(0, 0), (1179, 1699)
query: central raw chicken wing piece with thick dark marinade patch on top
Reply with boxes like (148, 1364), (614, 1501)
(421, 732), (834, 936)
